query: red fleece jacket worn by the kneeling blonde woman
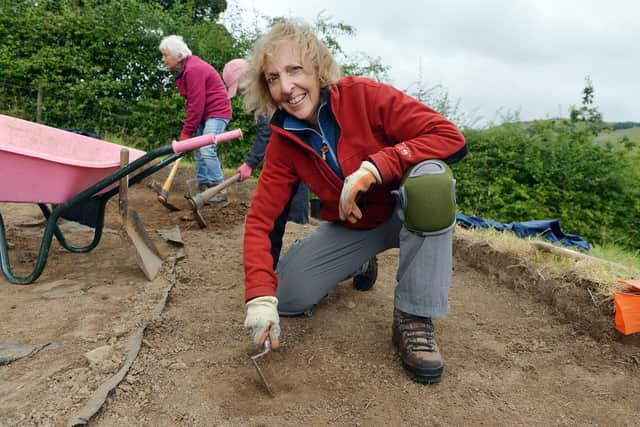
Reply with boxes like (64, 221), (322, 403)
(244, 77), (466, 300)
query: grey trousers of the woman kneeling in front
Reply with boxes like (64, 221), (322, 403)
(277, 207), (455, 317)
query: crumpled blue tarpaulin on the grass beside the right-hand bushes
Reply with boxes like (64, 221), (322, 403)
(456, 213), (591, 252)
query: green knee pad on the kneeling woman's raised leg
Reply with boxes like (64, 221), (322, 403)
(396, 160), (456, 232)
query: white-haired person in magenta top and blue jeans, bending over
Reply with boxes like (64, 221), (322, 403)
(160, 35), (232, 203)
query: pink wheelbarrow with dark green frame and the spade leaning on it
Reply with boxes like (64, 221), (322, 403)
(0, 115), (242, 284)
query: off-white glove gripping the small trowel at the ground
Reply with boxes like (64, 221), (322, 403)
(244, 297), (280, 350)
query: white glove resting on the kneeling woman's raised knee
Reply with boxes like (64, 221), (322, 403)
(338, 160), (382, 223)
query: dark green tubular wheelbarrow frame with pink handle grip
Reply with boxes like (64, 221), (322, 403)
(0, 129), (242, 285)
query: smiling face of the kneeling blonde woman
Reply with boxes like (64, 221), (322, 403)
(262, 41), (320, 127)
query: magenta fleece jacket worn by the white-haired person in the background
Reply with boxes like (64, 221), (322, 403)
(176, 55), (231, 136)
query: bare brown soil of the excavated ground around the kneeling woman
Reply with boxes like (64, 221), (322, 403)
(0, 167), (640, 426)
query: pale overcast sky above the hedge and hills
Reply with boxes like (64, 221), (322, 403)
(221, 0), (640, 127)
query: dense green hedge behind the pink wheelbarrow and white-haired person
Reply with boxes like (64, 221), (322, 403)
(0, 0), (236, 149)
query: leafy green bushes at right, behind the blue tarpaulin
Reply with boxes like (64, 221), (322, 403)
(454, 109), (640, 248)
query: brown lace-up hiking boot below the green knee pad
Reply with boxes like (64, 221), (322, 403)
(392, 308), (444, 384)
